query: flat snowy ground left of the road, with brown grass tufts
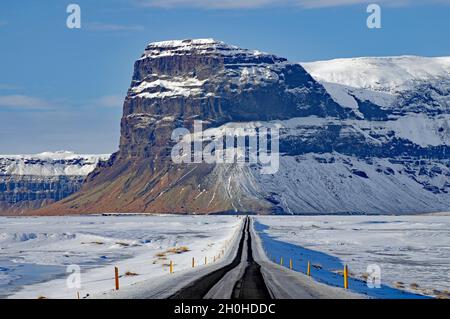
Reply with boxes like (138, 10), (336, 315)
(0, 216), (241, 298)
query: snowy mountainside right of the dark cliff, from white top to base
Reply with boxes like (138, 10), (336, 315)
(254, 56), (450, 214)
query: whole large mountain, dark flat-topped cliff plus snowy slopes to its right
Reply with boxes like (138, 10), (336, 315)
(34, 39), (450, 214)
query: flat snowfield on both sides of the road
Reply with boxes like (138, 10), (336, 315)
(0, 215), (450, 299)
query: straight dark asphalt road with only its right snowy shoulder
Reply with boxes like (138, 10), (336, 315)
(169, 217), (362, 299)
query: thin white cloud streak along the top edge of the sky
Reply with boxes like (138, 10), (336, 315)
(133, 0), (450, 9)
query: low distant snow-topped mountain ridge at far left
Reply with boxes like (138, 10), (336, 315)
(0, 152), (109, 215)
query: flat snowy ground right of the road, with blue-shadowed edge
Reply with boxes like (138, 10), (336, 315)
(256, 215), (450, 298)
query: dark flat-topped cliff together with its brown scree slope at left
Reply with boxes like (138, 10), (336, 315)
(37, 40), (353, 213)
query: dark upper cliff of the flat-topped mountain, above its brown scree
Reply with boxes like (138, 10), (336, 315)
(119, 40), (350, 158)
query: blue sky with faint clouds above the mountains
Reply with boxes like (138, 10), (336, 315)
(0, 0), (450, 154)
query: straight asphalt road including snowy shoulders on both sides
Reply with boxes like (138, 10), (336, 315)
(93, 217), (365, 299)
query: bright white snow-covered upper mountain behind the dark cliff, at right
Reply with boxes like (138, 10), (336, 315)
(301, 56), (450, 119)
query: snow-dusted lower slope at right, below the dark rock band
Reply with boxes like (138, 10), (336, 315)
(253, 153), (450, 214)
